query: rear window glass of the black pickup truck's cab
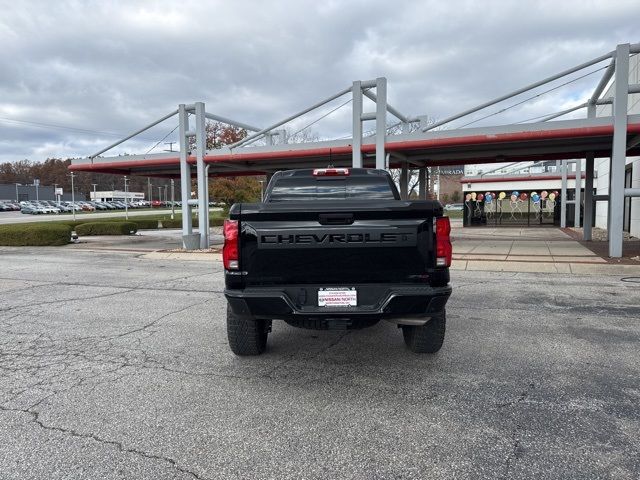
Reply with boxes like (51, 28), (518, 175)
(268, 176), (395, 202)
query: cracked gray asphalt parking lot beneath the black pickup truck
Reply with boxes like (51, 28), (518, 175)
(0, 247), (640, 480)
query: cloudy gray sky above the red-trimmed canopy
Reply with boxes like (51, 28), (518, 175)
(0, 0), (640, 162)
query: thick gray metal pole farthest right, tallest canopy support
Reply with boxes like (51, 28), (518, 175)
(609, 43), (630, 258)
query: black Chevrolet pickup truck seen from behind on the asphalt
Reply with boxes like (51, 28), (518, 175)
(223, 168), (451, 355)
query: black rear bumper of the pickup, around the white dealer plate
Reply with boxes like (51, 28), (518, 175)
(224, 284), (451, 320)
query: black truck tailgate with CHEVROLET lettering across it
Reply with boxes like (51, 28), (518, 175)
(232, 200), (441, 286)
